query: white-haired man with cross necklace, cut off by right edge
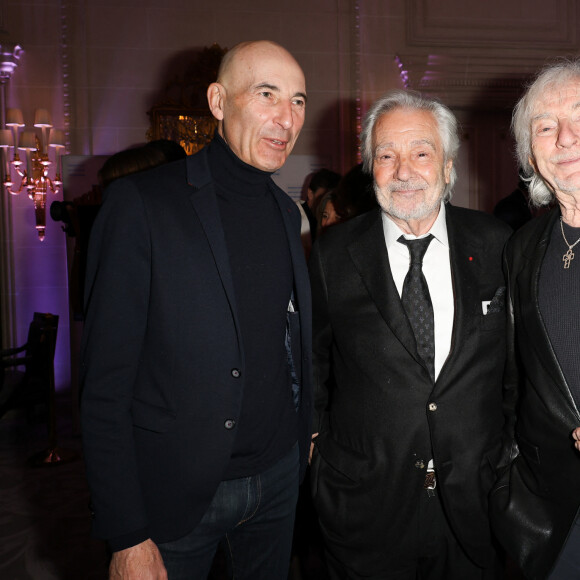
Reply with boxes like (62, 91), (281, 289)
(491, 60), (580, 580)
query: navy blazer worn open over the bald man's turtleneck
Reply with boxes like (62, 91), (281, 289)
(82, 145), (311, 545)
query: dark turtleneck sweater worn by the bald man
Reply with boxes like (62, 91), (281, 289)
(208, 133), (298, 479)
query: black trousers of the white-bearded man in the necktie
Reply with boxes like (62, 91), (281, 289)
(326, 490), (502, 580)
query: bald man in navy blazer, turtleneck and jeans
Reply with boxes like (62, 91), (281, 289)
(82, 41), (311, 580)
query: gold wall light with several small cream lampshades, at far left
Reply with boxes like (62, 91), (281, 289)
(0, 109), (65, 241)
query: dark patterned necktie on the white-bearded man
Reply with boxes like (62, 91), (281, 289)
(397, 234), (435, 380)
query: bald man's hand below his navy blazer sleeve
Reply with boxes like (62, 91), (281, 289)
(109, 540), (167, 580)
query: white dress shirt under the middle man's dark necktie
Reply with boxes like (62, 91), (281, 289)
(382, 202), (455, 380)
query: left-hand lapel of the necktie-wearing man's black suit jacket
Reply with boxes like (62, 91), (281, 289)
(348, 210), (425, 367)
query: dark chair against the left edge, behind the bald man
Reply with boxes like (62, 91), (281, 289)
(0, 312), (58, 422)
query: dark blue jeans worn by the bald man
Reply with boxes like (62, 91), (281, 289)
(158, 444), (299, 580)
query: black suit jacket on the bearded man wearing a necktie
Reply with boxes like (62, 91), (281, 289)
(310, 205), (510, 577)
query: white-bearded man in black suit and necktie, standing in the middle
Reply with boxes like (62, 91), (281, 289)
(310, 91), (510, 580)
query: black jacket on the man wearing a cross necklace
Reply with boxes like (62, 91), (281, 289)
(491, 208), (580, 579)
